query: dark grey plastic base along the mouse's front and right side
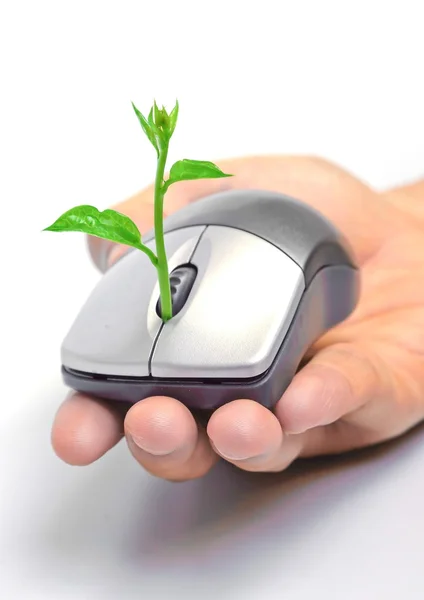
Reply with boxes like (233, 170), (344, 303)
(62, 266), (359, 410)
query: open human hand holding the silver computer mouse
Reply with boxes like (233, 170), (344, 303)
(52, 156), (424, 481)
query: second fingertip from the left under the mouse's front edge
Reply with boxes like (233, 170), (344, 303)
(124, 397), (218, 481)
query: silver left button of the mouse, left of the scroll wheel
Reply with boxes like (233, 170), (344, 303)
(61, 226), (205, 377)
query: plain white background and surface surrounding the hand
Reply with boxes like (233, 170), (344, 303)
(0, 0), (424, 600)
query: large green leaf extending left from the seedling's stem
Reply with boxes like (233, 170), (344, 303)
(44, 204), (157, 264)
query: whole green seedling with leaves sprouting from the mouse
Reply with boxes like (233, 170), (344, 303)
(44, 101), (232, 321)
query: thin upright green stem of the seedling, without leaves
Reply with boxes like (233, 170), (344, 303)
(154, 144), (172, 321)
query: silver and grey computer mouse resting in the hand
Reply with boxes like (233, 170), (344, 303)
(61, 190), (360, 411)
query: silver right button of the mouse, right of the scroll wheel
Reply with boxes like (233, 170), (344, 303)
(151, 226), (305, 379)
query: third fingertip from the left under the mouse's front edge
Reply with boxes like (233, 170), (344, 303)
(207, 400), (302, 471)
